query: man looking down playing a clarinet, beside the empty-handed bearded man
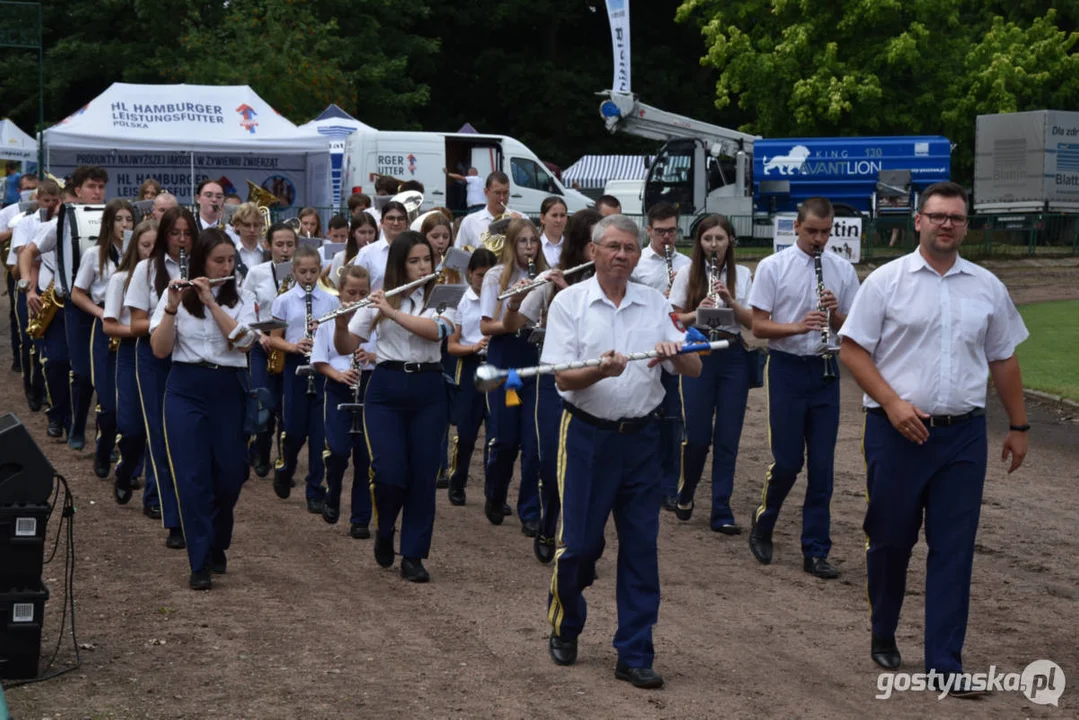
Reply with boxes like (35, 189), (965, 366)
(749, 198), (858, 580)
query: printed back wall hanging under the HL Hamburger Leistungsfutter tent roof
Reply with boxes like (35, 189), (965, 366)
(50, 150), (308, 208)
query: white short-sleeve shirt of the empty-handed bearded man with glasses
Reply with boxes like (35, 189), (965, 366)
(839, 250), (1029, 415)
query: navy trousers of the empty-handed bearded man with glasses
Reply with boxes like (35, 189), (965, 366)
(863, 415), (988, 673)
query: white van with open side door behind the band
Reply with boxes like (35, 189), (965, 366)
(341, 132), (592, 216)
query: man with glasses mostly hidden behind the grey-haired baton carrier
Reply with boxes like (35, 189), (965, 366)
(630, 203), (689, 511)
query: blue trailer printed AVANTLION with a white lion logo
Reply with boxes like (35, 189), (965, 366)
(752, 135), (952, 217)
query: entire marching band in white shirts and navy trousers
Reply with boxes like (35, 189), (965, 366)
(0, 166), (1028, 688)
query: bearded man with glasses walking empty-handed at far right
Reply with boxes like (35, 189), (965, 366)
(839, 182), (1030, 695)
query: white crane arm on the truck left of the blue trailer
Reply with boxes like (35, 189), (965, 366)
(599, 90), (761, 155)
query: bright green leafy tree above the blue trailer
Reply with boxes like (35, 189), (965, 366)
(677, 0), (1079, 181)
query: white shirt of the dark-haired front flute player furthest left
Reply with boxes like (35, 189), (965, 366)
(150, 287), (258, 368)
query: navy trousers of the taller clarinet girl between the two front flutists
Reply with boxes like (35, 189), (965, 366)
(274, 353), (326, 500)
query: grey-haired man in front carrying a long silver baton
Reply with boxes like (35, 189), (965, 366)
(543, 215), (700, 688)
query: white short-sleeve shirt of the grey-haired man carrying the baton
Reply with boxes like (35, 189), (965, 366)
(542, 277), (685, 420)
